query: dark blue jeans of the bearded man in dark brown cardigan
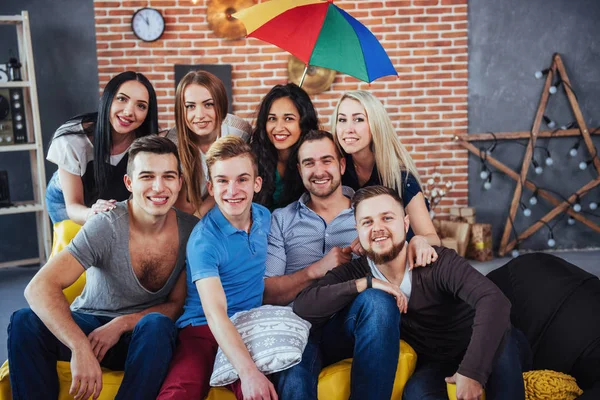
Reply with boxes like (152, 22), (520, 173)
(402, 328), (526, 400)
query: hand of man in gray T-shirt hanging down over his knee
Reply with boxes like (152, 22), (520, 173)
(69, 347), (102, 400)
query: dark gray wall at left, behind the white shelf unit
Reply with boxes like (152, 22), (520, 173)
(0, 0), (99, 262)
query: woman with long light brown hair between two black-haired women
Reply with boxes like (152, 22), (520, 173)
(167, 71), (252, 217)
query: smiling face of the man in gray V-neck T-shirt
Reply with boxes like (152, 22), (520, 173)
(125, 152), (181, 216)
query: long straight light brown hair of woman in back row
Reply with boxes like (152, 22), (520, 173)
(175, 71), (228, 210)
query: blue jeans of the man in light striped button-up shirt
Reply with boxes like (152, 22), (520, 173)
(275, 289), (400, 400)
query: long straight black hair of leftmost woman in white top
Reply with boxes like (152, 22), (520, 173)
(94, 71), (158, 192)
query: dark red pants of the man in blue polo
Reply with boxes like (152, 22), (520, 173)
(157, 325), (244, 400)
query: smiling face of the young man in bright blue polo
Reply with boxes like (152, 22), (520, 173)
(208, 154), (262, 222)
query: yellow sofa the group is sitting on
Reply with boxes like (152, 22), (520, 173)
(0, 220), (417, 400)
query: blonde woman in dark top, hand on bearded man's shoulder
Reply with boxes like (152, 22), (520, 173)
(331, 90), (441, 268)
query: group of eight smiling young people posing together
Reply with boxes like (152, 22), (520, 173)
(8, 71), (524, 400)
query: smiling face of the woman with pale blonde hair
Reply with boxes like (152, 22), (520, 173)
(335, 98), (373, 154)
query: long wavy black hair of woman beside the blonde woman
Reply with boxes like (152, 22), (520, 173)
(250, 83), (319, 208)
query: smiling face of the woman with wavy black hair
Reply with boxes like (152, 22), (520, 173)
(266, 97), (302, 151)
